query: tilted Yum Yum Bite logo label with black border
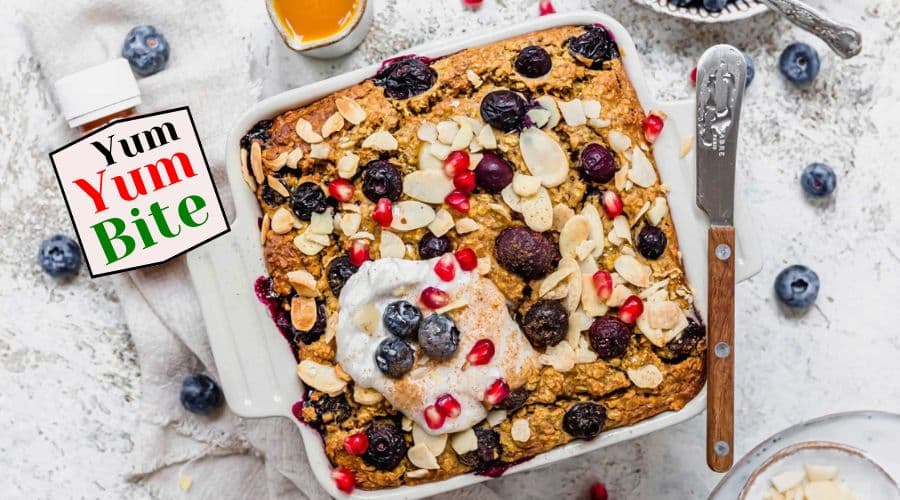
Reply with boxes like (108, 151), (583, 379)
(50, 107), (229, 278)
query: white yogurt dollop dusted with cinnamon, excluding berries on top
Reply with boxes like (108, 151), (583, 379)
(336, 259), (539, 435)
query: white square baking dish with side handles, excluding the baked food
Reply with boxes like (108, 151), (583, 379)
(188, 11), (762, 500)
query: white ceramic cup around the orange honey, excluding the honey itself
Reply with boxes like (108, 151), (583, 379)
(266, 0), (375, 59)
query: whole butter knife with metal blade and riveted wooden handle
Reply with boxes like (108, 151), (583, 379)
(696, 45), (747, 472)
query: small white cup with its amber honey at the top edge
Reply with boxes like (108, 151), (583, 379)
(266, 0), (374, 58)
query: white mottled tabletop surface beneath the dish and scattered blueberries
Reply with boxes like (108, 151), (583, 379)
(0, 0), (900, 499)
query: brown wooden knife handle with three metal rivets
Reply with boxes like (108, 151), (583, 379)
(706, 226), (734, 472)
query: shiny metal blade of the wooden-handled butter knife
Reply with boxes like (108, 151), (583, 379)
(696, 45), (747, 226)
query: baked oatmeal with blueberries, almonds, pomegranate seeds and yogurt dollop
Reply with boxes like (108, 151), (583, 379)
(241, 26), (706, 489)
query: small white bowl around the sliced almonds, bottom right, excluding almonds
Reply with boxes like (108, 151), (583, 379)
(739, 441), (900, 500)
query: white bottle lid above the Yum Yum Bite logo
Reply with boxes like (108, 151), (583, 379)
(53, 57), (141, 128)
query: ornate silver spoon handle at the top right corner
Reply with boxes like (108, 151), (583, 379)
(759, 0), (862, 59)
